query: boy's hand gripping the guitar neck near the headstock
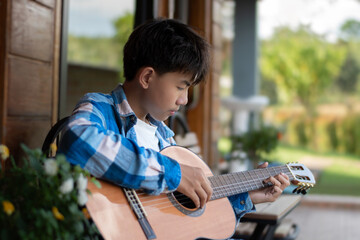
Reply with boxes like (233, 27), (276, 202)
(249, 162), (290, 204)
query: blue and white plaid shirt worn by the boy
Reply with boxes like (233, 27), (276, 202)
(59, 85), (253, 217)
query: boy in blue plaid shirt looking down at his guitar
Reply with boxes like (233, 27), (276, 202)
(59, 19), (289, 238)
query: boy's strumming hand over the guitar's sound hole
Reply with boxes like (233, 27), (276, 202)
(177, 164), (213, 208)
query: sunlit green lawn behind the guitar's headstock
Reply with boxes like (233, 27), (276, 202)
(266, 146), (360, 196)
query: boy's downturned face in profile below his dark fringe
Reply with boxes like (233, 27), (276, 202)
(144, 72), (191, 121)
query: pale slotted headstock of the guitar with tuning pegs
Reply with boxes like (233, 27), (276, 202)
(286, 163), (316, 194)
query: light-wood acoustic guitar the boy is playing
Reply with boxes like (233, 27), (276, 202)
(86, 146), (315, 240)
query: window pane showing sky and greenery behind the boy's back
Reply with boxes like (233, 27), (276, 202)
(60, 0), (135, 117)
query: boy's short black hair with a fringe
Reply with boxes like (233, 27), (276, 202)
(124, 19), (210, 85)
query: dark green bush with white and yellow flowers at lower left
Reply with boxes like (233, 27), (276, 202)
(0, 145), (100, 240)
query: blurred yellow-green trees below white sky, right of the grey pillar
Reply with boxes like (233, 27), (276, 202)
(260, 20), (360, 109)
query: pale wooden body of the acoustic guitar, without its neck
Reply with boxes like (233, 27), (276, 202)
(86, 146), (236, 240)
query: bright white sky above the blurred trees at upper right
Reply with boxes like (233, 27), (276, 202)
(258, 0), (360, 41)
